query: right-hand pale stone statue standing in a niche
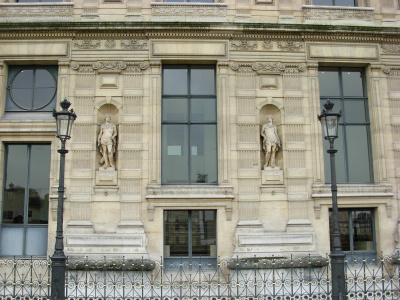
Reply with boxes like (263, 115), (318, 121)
(261, 115), (281, 169)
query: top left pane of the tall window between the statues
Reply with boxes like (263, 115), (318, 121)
(163, 68), (188, 95)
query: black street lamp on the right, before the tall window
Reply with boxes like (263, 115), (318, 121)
(318, 101), (346, 300)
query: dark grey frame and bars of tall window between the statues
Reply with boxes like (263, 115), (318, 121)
(161, 64), (218, 185)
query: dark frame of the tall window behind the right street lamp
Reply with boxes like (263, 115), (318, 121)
(318, 66), (374, 184)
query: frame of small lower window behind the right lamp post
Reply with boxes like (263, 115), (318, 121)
(329, 207), (377, 256)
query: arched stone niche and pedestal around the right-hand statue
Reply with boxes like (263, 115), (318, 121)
(259, 104), (283, 185)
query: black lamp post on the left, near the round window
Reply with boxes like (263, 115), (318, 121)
(51, 98), (76, 300)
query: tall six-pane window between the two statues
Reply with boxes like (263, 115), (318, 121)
(161, 65), (217, 184)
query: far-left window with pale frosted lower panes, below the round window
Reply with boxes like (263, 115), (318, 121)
(0, 144), (50, 256)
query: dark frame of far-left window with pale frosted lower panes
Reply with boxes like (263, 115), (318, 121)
(0, 142), (51, 257)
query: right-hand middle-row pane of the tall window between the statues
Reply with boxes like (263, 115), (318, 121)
(190, 98), (217, 122)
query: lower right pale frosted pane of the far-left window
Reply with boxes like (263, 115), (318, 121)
(25, 226), (47, 256)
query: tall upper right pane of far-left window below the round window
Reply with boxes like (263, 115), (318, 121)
(28, 145), (50, 225)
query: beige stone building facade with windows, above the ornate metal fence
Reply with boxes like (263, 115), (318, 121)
(0, 0), (400, 259)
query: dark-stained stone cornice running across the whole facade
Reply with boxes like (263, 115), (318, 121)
(0, 22), (400, 44)
